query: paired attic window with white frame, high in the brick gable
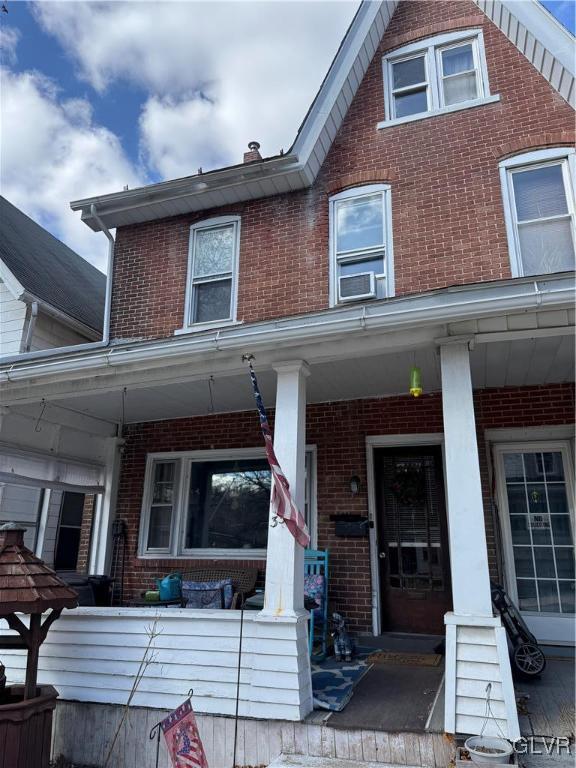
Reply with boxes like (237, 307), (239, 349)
(379, 29), (492, 127)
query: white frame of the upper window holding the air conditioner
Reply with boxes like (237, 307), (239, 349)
(329, 184), (394, 307)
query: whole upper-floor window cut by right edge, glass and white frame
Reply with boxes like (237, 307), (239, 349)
(500, 148), (576, 277)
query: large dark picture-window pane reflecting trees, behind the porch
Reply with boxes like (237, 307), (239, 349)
(185, 459), (271, 550)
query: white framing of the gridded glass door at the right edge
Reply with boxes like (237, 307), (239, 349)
(493, 439), (576, 642)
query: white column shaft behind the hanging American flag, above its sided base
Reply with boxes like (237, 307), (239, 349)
(263, 360), (310, 616)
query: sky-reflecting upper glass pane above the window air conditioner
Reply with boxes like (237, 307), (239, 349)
(336, 193), (384, 253)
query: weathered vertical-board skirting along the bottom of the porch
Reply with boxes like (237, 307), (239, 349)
(52, 701), (454, 768)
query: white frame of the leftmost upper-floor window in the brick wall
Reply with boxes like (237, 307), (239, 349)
(181, 216), (240, 333)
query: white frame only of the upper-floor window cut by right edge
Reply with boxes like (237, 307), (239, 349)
(499, 147), (576, 277)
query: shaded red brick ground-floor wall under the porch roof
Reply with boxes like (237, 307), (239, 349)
(111, 385), (574, 631)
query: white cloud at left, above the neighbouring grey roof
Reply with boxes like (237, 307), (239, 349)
(0, 69), (141, 269)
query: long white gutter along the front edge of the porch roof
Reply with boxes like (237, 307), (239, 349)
(0, 277), (574, 382)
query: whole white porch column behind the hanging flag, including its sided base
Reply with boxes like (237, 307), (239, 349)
(251, 360), (312, 720)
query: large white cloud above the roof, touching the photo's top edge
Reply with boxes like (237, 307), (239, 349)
(35, 0), (358, 178)
